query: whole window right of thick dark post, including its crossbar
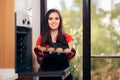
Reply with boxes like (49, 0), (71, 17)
(91, 0), (120, 80)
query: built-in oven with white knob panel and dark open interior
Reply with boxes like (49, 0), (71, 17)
(15, 12), (32, 75)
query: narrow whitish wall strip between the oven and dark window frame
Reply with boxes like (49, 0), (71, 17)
(32, 0), (40, 80)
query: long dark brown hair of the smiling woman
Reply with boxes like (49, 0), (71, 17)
(41, 9), (66, 46)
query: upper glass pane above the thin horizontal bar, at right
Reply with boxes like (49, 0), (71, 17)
(91, 0), (120, 55)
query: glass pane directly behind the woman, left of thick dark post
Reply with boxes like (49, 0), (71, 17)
(47, 0), (83, 80)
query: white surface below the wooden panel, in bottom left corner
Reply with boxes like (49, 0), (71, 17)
(0, 68), (18, 80)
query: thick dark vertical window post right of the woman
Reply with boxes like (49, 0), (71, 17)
(83, 0), (91, 80)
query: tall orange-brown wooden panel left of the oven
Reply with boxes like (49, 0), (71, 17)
(0, 0), (15, 68)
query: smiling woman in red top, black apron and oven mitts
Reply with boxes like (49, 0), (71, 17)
(34, 9), (75, 80)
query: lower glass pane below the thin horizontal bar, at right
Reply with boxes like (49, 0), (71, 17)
(91, 58), (120, 80)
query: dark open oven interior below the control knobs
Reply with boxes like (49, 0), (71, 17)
(15, 26), (32, 73)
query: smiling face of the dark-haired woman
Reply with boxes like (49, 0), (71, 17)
(48, 12), (60, 30)
